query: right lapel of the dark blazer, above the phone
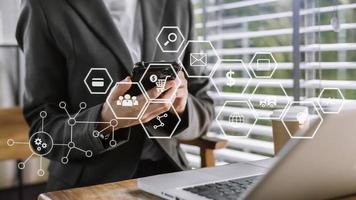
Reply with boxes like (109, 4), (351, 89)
(141, 0), (166, 61)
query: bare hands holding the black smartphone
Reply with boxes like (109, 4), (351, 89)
(101, 77), (178, 130)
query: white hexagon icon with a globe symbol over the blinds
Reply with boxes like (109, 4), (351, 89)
(215, 101), (257, 138)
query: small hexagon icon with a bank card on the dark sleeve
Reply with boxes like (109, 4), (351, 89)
(84, 68), (113, 94)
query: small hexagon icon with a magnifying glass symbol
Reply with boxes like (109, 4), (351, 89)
(156, 26), (185, 53)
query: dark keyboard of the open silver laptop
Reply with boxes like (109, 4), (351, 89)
(183, 176), (261, 200)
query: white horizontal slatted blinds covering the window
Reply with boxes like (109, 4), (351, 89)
(183, 0), (356, 167)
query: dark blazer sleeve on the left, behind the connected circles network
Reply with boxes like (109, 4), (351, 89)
(16, 0), (129, 161)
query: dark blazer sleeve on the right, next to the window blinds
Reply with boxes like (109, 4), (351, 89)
(175, 1), (214, 140)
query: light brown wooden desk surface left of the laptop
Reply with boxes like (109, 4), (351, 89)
(38, 179), (160, 200)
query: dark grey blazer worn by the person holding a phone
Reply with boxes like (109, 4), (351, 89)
(17, 0), (213, 190)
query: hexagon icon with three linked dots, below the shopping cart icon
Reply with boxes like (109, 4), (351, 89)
(139, 101), (181, 139)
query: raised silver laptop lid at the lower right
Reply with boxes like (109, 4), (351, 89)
(247, 110), (356, 200)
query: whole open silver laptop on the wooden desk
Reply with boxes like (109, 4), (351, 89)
(138, 110), (356, 200)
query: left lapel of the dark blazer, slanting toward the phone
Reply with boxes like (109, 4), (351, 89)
(67, 0), (133, 74)
